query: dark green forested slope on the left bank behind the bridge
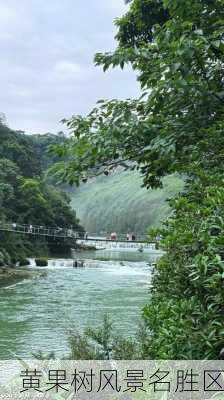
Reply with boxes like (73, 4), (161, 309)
(0, 122), (82, 265)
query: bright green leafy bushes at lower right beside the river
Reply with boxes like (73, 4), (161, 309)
(144, 170), (224, 359)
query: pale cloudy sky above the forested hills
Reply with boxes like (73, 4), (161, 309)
(0, 0), (138, 133)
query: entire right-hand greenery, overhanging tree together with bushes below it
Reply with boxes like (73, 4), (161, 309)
(52, 0), (224, 358)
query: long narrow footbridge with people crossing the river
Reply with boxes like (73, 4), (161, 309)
(0, 222), (162, 252)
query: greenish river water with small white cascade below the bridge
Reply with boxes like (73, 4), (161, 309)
(0, 251), (158, 359)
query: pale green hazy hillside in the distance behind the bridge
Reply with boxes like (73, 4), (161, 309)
(72, 171), (183, 233)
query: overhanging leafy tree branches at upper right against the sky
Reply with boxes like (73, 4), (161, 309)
(53, 0), (224, 187)
